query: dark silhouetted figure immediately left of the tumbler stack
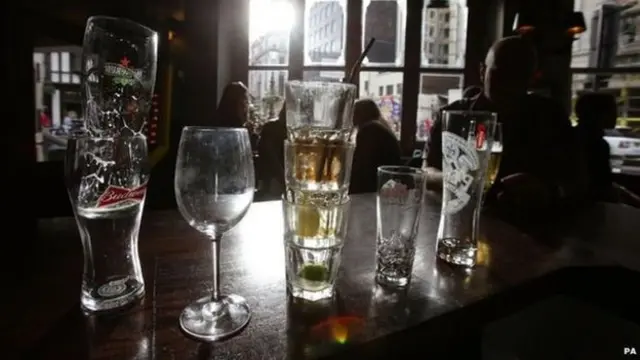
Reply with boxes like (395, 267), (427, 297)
(258, 105), (287, 197)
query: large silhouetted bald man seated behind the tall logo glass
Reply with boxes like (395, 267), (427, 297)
(427, 36), (586, 221)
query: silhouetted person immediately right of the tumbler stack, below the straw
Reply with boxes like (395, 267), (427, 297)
(350, 99), (401, 193)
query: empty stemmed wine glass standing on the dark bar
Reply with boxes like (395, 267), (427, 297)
(174, 126), (255, 341)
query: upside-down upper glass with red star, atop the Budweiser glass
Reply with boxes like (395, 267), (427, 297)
(82, 16), (158, 137)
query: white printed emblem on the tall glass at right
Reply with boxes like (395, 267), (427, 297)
(442, 131), (479, 215)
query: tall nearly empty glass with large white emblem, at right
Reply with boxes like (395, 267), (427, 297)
(437, 111), (497, 267)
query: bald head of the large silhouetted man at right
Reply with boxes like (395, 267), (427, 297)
(483, 36), (537, 107)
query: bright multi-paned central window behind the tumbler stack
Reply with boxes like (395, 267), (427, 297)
(249, 0), (467, 150)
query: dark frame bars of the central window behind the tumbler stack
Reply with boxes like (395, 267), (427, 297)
(245, 0), (471, 155)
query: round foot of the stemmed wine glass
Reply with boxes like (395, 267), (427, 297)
(180, 295), (251, 342)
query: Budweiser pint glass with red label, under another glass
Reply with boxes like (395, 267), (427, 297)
(65, 135), (149, 311)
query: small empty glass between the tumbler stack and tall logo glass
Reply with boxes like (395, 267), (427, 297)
(376, 166), (426, 287)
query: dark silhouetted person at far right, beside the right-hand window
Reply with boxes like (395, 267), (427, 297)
(575, 92), (618, 201)
